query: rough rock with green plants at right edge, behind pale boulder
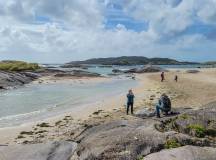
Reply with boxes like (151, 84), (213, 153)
(157, 102), (216, 141)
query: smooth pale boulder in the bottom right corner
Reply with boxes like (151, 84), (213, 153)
(144, 146), (216, 160)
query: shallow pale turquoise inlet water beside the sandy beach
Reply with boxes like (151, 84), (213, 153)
(0, 79), (137, 127)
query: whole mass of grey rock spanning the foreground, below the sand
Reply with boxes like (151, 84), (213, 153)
(5, 103), (216, 160)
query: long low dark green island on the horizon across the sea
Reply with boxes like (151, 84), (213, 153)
(66, 56), (199, 65)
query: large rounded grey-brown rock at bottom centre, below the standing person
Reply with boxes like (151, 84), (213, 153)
(74, 119), (166, 160)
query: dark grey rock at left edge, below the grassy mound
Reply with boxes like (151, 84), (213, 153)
(0, 71), (40, 89)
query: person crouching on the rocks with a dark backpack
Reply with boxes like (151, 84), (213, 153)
(156, 93), (171, 118)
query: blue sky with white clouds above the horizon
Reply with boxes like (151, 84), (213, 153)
(0, 0), (216, 63)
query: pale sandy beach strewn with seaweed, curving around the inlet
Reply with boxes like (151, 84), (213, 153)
(0, 69), (216, 145)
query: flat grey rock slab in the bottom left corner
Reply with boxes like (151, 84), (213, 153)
(0, 141), (77, 160)
